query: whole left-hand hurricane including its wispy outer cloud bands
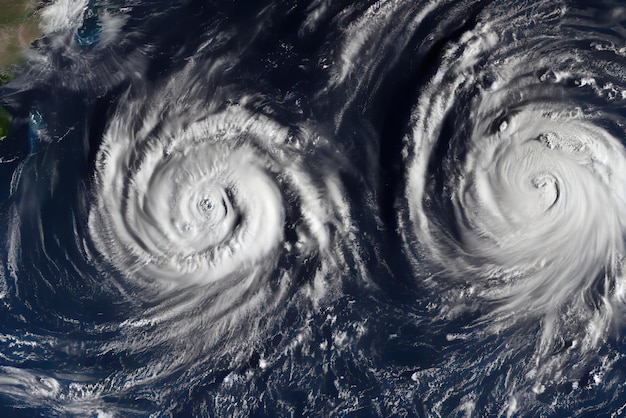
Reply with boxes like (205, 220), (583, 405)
(88, 72), (348, 386)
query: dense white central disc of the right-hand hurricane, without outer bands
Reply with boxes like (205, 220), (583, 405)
(446, 104), (626, 310)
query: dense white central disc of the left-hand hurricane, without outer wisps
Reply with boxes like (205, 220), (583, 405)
(91, 110), (287, 290)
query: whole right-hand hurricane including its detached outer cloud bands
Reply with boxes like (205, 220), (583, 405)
(398, 5), (626, 386)
